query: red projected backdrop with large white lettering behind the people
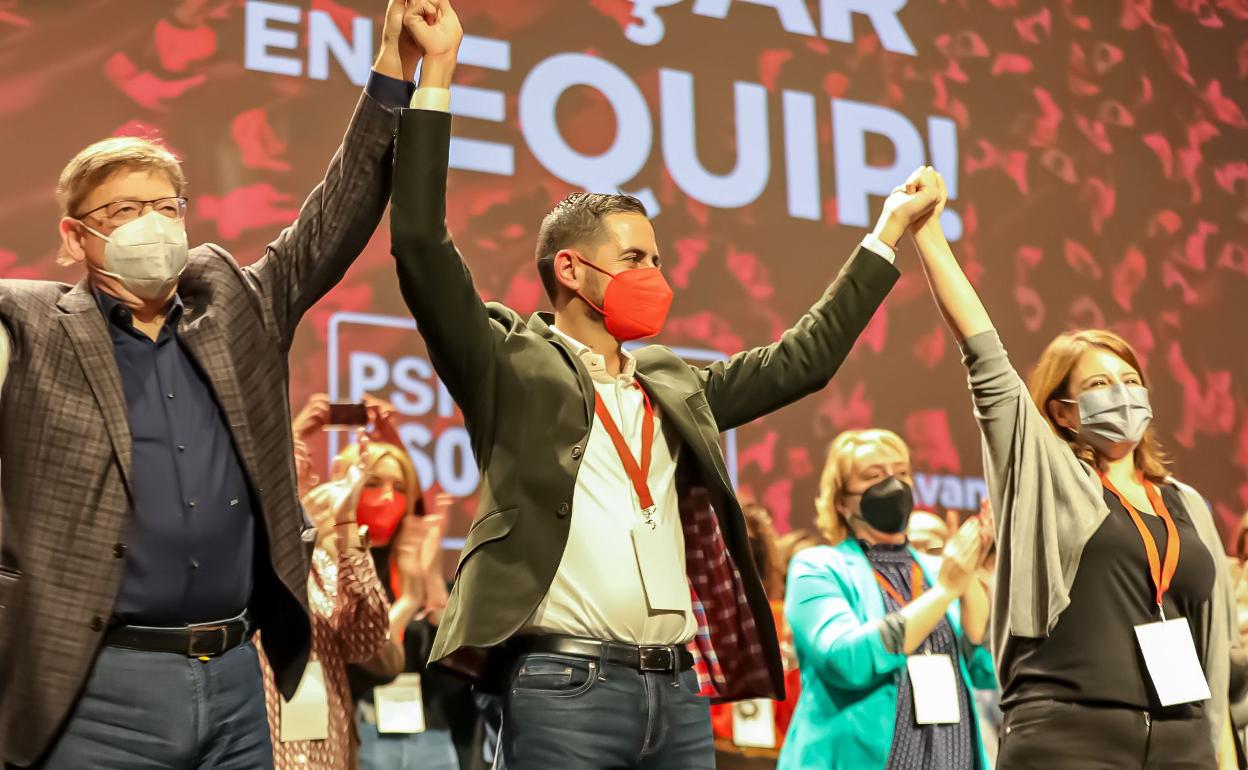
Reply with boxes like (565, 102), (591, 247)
(0, 0), (1248, 549)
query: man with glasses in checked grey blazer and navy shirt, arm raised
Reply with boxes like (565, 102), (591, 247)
(0, 0), (433, 770)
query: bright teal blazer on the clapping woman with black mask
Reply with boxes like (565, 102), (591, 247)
(778, 538), (997, 770)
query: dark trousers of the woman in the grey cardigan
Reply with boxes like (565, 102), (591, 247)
(997, 700), (1217, 770)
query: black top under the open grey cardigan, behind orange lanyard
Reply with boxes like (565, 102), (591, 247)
(1001, 484), (1216, 718)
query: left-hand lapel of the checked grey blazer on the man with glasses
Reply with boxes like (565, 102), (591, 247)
(56, 278), (134, 494)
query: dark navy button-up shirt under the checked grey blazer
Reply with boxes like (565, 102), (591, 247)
(96, 292), (256, 625)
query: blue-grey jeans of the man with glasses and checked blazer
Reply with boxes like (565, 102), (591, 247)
(28, 641), (273, 770)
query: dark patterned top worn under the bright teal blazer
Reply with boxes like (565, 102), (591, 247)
(862, 543), (980, 770)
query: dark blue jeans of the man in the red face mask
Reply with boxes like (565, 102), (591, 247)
(499, 653), (715, 770)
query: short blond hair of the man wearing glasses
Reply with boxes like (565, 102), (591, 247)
(56, 136), (186, 265)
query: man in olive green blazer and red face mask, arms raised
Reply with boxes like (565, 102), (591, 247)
(391, 12), (934, 770)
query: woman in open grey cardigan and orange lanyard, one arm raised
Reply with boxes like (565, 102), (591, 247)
(888, 167), (1236, 770)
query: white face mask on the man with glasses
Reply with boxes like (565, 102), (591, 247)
(82, 211), (188, 300)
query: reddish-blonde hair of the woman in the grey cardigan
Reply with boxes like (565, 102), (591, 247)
(1027, 329), (1169, 483)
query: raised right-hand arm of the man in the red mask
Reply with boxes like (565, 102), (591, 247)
(699, 182), (936, 431)
